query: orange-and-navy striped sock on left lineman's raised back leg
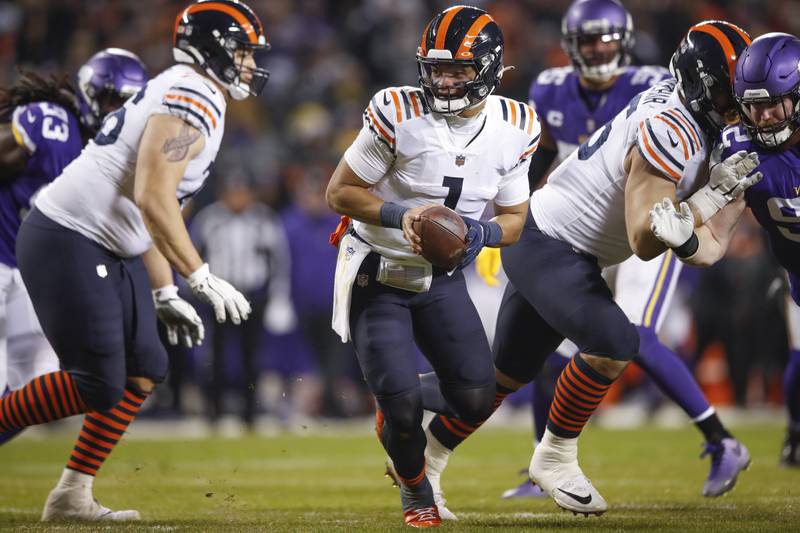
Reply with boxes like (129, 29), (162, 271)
(0, 370), (89, 432)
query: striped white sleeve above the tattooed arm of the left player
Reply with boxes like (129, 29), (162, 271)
(153, 76), (225, 137)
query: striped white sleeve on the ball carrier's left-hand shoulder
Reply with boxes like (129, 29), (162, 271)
(344, 90), (396, 183)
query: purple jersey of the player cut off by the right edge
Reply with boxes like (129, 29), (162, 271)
(722, 125), (800, 305)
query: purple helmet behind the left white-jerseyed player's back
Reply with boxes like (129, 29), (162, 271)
(78, 48), (147, 130)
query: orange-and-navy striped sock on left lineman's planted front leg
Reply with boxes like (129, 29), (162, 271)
(67, 385), (148, 476)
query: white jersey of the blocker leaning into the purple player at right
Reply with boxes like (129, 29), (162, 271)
(531, 79), (711, 267)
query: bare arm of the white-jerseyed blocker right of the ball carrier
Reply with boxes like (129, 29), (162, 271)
(625, 146), (675, 261)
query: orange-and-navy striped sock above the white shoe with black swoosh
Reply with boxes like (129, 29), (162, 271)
(547, 354), (613, 439)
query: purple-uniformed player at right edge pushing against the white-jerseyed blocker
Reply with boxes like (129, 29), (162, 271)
(650, 33), (800, 466)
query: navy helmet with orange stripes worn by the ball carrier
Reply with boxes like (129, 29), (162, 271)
(417, 6), (504, 114)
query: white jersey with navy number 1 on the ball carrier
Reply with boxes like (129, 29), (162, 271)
(344, 87), (541, 261)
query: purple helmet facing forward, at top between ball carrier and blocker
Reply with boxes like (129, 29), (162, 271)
(561, 0), (633, 82)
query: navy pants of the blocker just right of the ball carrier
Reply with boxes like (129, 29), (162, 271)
(493, 213), (639, 383)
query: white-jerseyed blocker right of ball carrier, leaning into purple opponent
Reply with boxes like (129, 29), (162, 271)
(416, 21), (759, 515)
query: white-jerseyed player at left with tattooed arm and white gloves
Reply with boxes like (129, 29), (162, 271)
(0, 0), (268, 520)
